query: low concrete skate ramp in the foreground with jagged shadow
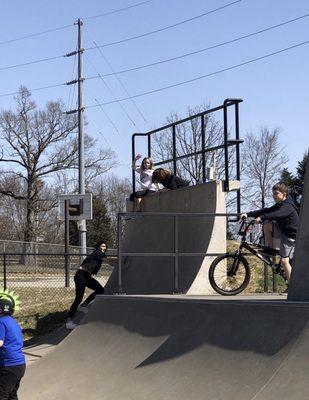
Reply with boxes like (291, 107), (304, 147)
(20, 296), (309, 400)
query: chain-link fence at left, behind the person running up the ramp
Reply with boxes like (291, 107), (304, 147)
(0, 250), (115, 315)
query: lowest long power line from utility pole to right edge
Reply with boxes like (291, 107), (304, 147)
(85, 40), (309, 108)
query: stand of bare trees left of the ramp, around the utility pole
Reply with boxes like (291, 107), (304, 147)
(0, 87), (129, 245)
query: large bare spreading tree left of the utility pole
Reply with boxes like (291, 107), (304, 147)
(0, 87), (115, 241)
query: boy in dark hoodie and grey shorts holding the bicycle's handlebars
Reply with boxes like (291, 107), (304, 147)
(241, 182), (299, 281)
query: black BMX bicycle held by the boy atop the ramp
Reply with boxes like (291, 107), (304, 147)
(209, 219), (287, 296)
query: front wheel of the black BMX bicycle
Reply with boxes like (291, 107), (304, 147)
(209, 254), (250, 296)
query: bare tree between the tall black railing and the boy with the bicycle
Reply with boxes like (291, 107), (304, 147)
(242, 127), (288, 208)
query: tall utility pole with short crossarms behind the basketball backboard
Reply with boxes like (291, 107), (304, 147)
(66, 19), (87, 255)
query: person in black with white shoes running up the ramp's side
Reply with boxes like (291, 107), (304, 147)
(66, 241), (107, 329)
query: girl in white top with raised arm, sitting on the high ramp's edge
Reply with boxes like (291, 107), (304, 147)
(130, 154), (163, 211)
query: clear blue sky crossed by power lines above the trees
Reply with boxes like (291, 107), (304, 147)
(0, 0), (309, 176)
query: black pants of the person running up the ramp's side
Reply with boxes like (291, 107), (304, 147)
(68, 269), (104, 318)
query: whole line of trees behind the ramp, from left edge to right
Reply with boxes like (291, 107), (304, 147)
(0, 91), (308, 250)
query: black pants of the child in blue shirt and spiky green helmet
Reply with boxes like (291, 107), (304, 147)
(0, 364), (26, 400)
